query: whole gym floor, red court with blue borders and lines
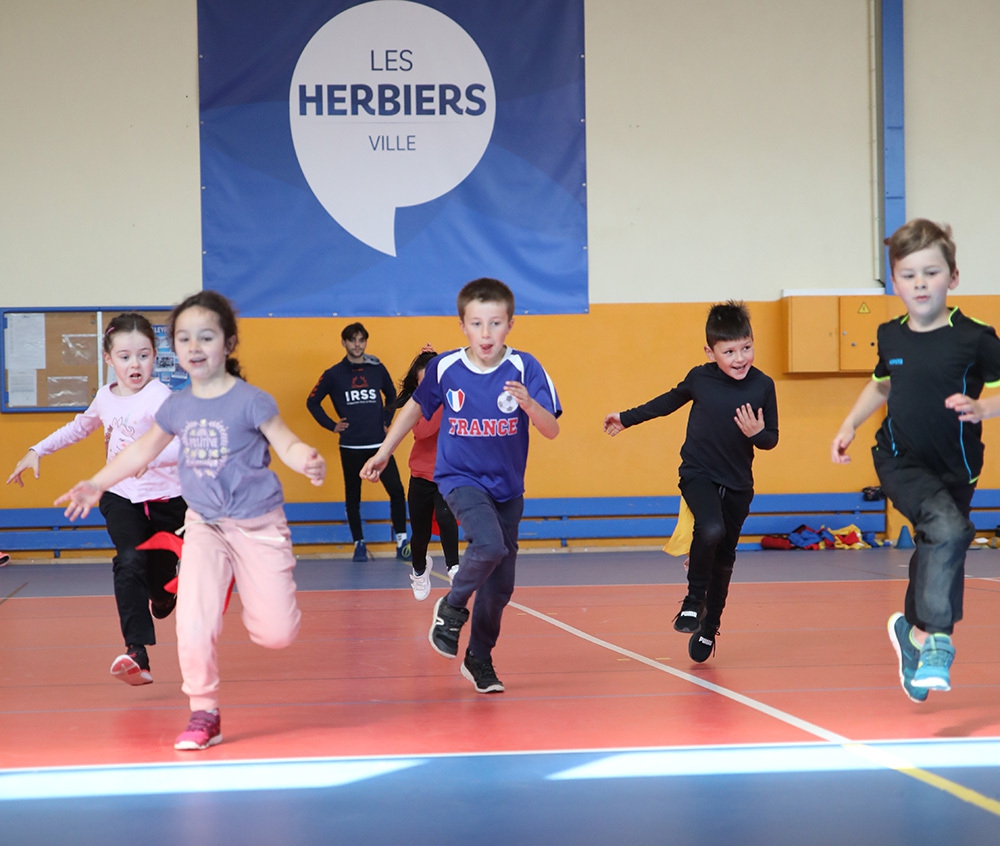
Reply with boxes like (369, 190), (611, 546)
(0, 549), (1000, 846)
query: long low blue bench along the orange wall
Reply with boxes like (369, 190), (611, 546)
(0, 490), (896, 558)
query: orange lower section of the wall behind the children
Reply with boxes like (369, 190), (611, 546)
(0, 296), (1000, 508)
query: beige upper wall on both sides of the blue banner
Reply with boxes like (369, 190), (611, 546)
(0, 0), (1000, 306)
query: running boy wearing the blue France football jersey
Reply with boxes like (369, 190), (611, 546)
(361, 279), (562, 693)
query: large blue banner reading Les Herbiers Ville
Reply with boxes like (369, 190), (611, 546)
(198, 0), (588, 317)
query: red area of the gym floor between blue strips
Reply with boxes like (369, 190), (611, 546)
(0, 579), (1000, 767)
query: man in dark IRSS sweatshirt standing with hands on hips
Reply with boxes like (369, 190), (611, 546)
(306, 323), (410, 561)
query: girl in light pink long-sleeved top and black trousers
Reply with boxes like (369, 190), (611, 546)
(7, 312), (187, 685)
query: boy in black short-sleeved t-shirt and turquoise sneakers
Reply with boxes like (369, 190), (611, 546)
(831, 218), (1000, 702)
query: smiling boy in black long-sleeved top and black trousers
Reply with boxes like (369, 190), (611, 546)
(604, 301), (778, 663)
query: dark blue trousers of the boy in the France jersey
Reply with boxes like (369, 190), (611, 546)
(444, 485), (524, 660)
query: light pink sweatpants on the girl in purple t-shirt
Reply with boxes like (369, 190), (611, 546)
(176, 507), (302, 711)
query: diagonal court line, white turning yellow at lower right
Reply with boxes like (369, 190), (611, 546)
(510, 601), (1000, 817)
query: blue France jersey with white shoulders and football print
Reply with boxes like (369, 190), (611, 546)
(413, 347), (562, 502)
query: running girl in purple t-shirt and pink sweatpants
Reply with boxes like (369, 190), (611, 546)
(56, 291), (326, 749)
